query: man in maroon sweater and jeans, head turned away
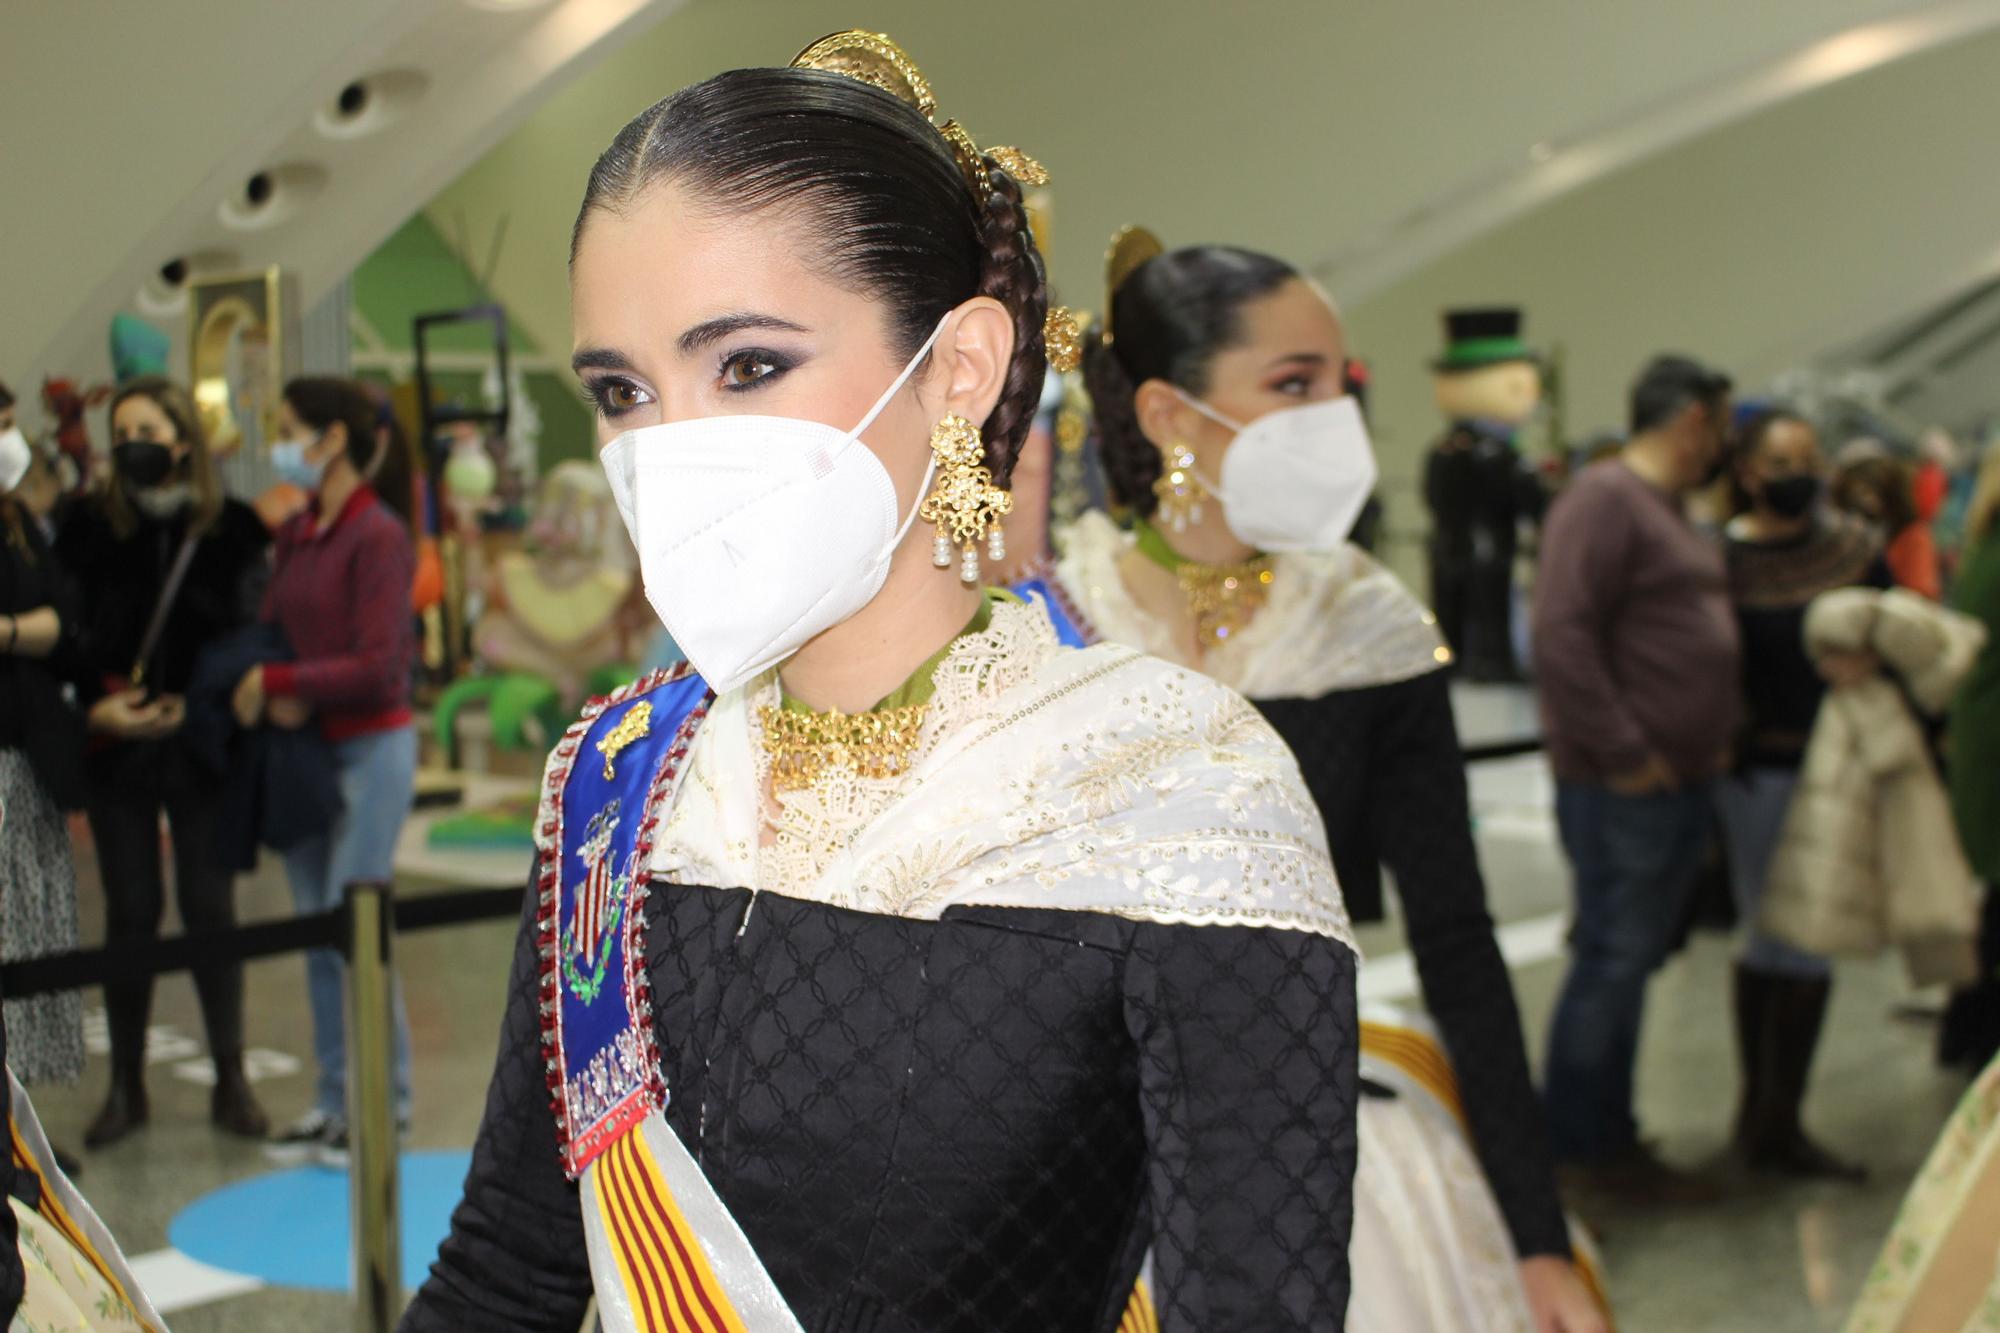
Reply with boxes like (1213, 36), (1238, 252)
(1534, 356), (1742, 1201)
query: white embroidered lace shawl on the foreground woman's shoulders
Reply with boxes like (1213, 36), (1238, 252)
(652, 602), (1354, 947)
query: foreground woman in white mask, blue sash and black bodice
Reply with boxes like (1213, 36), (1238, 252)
(416, 32), (1356, 1333)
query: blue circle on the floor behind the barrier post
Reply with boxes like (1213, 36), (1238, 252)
(166, 1151), (472, 1291)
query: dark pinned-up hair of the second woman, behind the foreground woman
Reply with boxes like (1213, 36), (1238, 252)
(1084, 246), (1298, 516)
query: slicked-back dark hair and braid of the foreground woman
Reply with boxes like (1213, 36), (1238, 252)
(570, 68), (1048, 484)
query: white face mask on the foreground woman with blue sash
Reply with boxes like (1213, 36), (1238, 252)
(598, 308), (944, 695)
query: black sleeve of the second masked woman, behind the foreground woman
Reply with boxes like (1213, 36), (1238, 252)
(1366, 673), (1570, 1257)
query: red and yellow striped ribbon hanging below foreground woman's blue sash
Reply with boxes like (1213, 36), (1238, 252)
(596, 1133), (746, 1333)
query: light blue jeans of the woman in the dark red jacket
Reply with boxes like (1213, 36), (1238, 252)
(284, 727), (416, 1117)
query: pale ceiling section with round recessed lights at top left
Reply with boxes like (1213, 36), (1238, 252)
(0, 0), (674, 392)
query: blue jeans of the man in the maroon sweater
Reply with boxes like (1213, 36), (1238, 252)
(1542, 783), (1712, 1161)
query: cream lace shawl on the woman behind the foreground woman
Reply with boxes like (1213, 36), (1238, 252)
(1056, 510), (1452, 699)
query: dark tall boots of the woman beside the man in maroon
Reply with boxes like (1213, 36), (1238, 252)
(1736, 965), (1868, 1183)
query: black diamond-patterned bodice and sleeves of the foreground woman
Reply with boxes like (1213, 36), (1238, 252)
(414, 887), (1358, 1333)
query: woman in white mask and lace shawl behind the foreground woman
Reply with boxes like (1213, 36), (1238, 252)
(1030, 228), (1606, 1333)
